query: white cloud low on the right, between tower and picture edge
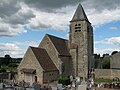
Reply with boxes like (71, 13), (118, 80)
(94, 37), (120, 55)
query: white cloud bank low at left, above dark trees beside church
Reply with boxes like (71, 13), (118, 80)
(0, 41), (38, 58)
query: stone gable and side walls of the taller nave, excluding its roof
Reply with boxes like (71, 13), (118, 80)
(39, 35), (71, 76)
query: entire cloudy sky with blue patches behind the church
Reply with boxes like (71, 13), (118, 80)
(0, 0), (120, 58)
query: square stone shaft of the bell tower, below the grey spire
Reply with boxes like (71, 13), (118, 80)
(69, 20), (94, 77)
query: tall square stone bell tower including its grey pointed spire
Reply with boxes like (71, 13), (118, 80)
(69, 4), (94, 78)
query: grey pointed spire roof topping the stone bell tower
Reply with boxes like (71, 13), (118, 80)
(71, 4), (88, 22)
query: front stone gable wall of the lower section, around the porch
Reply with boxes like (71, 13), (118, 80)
(17, 47), (43, 83)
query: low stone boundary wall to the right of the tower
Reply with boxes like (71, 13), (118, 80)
(95, 69), (120, 79)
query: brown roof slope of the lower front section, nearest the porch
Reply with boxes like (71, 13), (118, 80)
(30, 47), (58, 71)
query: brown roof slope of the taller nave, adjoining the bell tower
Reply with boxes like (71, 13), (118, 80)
(47, 34), (70, 56)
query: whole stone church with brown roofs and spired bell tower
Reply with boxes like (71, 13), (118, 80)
(17, 4), (94, 83)
